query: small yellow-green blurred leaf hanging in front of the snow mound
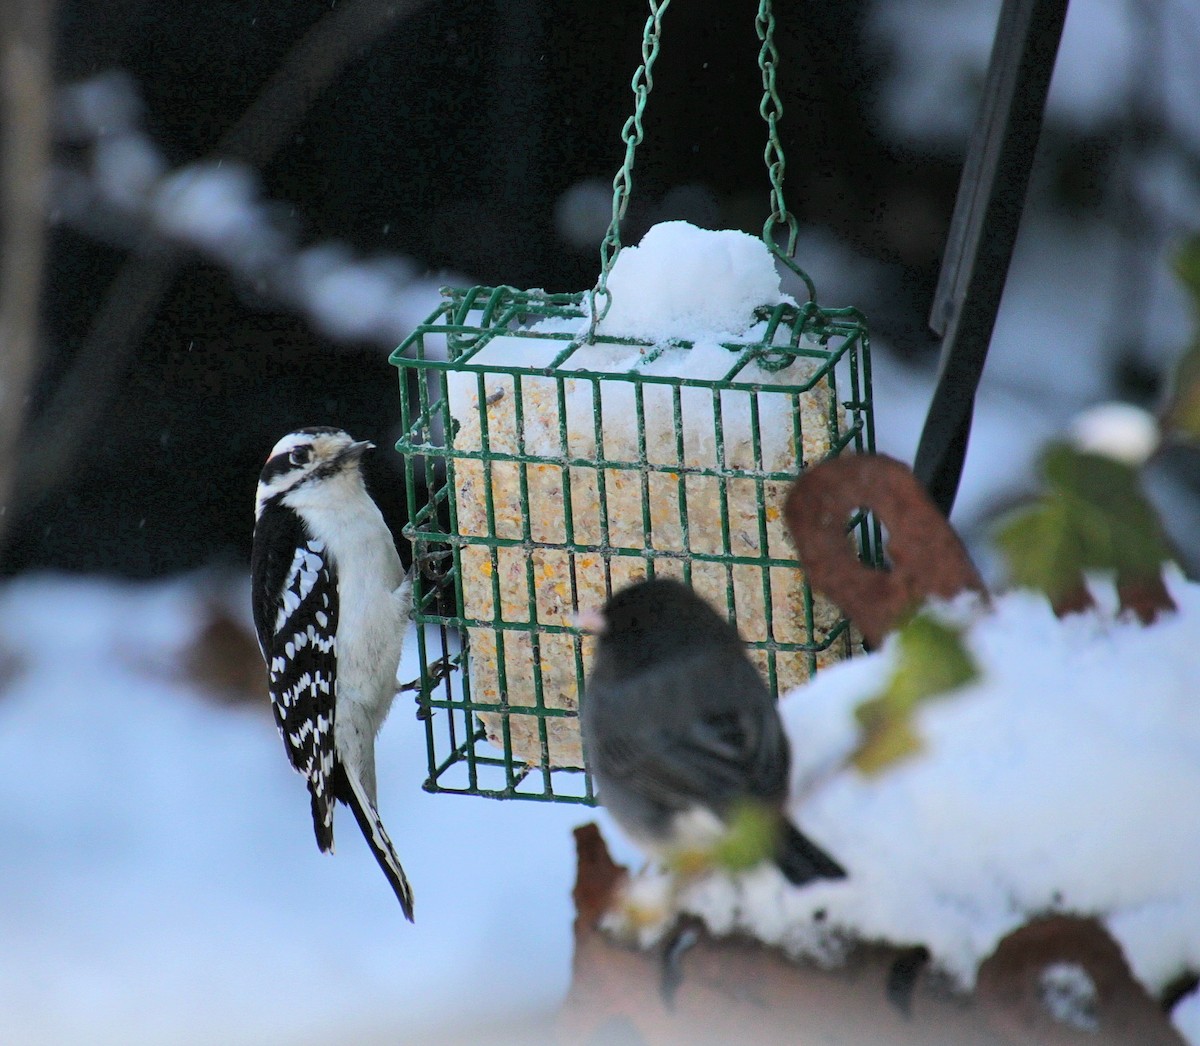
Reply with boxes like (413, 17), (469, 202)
(851, 614), (979, 774)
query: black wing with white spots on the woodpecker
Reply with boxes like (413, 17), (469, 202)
(251, 505), (337, 850)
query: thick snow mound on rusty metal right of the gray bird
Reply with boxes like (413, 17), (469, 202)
(685, 575), (1200, 1012)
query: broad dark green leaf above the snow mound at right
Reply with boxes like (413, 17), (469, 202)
(996, 444), (1172, 603)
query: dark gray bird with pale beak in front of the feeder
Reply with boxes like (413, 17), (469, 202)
(581, 578), (846, 885)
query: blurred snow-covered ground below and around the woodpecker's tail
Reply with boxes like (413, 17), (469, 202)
(0, 577), (589, 1046)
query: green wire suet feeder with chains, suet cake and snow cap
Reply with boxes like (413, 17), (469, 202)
(391, 0), (874, 801)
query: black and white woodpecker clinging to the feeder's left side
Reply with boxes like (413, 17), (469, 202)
(251, 427), (413, 921)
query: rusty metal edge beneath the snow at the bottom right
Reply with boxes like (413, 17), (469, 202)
(559, 825), (1188, 1046)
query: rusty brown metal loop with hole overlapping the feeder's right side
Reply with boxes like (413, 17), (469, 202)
(784, 455), (986, 647)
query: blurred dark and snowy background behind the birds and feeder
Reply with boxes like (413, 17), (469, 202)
(0, 0), (1200, 1042)
